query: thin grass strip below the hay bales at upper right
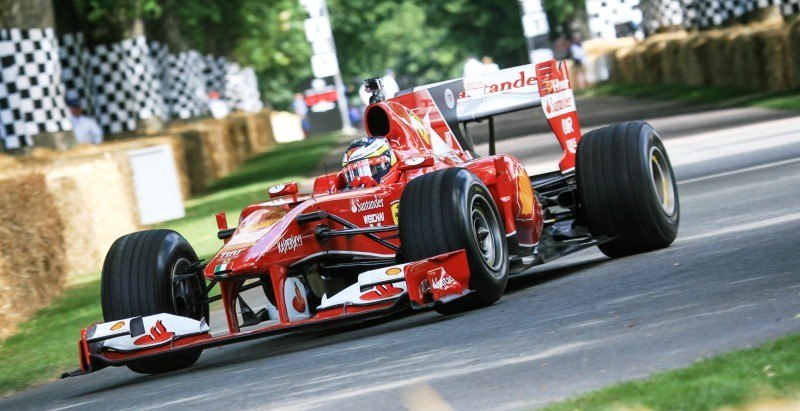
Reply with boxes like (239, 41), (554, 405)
(579, 84), (800, 111)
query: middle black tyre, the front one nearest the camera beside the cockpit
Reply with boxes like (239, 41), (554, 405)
(399, 168), (508, 314)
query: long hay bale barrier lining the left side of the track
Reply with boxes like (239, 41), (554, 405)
(0, 111), (282, 339)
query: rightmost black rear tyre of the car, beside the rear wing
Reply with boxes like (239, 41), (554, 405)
(575, 121), (680, 258)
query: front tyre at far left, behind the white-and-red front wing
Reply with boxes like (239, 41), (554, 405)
(100, 230), (208, 374)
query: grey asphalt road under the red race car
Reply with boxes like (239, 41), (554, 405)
(0, 98), (800, 410)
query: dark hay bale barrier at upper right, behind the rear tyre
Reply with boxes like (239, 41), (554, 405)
(589, 20), (800, 91)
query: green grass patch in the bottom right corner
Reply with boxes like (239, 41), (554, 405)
(545, 334), (800, 411)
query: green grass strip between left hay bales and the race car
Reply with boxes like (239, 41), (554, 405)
(0, 135), (338, 396)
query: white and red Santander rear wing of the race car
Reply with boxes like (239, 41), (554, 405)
(411, 60), (581, 173)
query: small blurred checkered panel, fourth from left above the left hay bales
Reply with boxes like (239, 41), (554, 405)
(161, 50), (207, 119)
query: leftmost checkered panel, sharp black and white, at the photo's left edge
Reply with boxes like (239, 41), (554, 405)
(0, 29), (72, 150)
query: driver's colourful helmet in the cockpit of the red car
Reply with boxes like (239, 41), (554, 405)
(342, 137), (397, 185)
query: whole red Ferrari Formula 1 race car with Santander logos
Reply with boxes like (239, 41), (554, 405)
(66, 60), (679, 376)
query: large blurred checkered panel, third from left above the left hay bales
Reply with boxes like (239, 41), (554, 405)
(89, 36), (166, 133)
